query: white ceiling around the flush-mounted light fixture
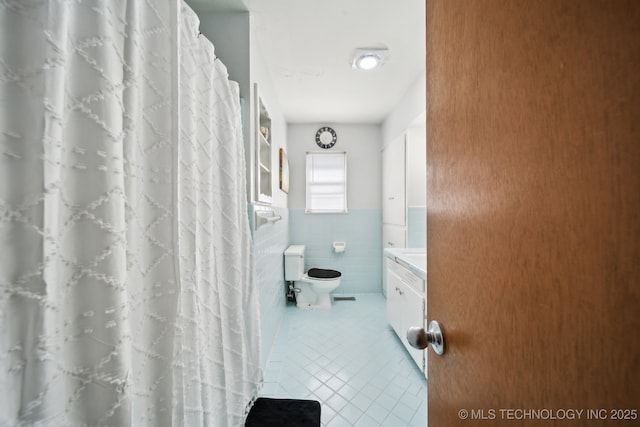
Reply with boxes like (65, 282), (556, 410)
(187, 0), (425, 123)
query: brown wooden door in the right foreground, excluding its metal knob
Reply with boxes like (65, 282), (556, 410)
(427, 0), (640, 427)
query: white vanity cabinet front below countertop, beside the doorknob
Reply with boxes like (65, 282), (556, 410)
(385, 258), (427, 376)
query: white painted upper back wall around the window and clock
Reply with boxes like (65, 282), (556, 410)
(287, 123), (382, 209)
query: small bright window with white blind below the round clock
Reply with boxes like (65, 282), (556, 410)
(305, 153), (347, 213)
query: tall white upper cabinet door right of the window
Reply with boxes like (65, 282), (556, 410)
(382, 135), (406, 225)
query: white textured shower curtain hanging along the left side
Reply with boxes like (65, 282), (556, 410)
(0, 0), (261, 426)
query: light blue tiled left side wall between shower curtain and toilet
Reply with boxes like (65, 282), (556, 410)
(249, 204), (289, 368)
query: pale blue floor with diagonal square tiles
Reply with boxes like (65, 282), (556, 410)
(260, 294), (427, 427)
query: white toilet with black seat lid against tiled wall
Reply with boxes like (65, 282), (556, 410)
(284, 245), (342, 309)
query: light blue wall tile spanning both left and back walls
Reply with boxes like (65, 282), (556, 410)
(249, 204), (382, 367)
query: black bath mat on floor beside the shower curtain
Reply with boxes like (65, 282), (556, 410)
(244, 397), (320, 427)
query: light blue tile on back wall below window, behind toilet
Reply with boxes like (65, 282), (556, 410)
(289, 209), (382, 294)
